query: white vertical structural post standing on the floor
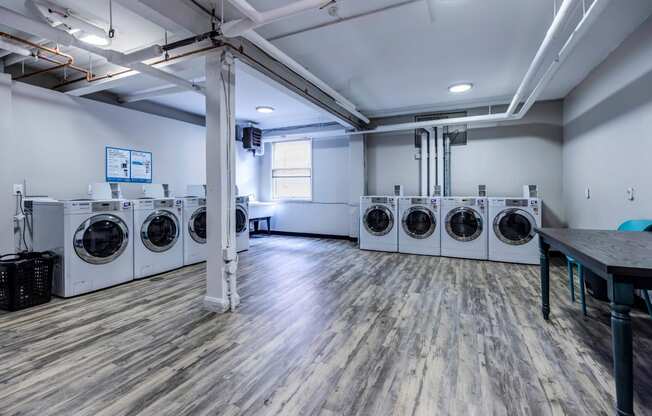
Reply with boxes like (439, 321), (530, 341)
(204, 49), (239, 312)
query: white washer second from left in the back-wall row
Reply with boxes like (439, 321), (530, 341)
(398, 196), (441, 256)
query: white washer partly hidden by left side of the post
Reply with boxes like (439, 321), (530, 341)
(183, 197), (208, 265)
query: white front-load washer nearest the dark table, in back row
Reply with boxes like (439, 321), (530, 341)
(489, 198), (541, 264)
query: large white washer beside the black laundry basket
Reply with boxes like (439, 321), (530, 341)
(29, 200), (134, 297)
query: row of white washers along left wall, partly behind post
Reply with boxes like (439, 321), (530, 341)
(25, 188), (249, 297)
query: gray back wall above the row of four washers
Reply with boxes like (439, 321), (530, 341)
(367, 101), (563, 226)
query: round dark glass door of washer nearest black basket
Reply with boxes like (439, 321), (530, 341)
(73, 214), (129, 264)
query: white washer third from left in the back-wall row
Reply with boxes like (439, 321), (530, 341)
(441, 197), (488, 260)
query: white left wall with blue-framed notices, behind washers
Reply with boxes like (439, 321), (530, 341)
(0, 79), (259, 252)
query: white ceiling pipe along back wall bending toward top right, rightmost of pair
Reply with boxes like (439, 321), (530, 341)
(338, 0), (611, 135)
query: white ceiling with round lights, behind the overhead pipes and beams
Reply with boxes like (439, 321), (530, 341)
(0, 0), (652, 123)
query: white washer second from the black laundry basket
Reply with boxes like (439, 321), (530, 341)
(132, 198), (183, 279)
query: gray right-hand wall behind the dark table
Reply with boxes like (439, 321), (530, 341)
(563, 13), (652, 229)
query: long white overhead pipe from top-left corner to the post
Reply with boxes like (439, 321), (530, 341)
(0, 6), (204, 94)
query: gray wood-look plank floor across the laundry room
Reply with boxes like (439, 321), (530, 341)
(0, 237), (652, 416)
